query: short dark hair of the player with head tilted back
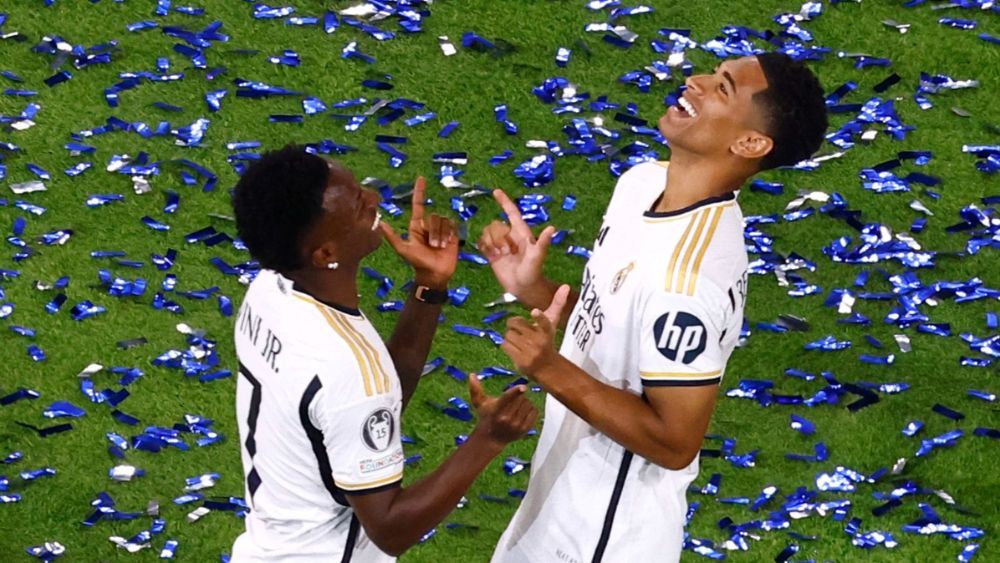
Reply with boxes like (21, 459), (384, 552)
(753, 53), (827, 170)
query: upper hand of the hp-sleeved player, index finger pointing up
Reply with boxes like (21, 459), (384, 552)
(478, 190), (556, 302)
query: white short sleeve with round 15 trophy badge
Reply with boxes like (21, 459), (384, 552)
(310, 384), (403, 494)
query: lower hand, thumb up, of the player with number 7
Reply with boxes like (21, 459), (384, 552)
(469, 373), (538, 449)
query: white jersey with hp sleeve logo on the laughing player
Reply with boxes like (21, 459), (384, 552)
(493, 163), (747, 563)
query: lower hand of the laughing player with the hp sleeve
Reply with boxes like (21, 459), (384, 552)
(500, 285), (569, 379)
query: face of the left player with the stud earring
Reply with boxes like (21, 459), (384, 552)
(303, 161), (382, 268)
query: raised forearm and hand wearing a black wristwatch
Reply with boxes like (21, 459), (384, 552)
(380, 177), (458, 408)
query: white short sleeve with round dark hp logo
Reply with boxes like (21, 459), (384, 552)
(639, 291), (725, 387)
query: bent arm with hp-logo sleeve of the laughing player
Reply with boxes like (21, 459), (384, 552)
(502, 286), (722, 469)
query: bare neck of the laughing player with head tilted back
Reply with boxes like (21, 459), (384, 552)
(653, 151), (749, 213)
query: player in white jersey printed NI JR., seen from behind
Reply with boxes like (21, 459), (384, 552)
(232, 146), (537, 563)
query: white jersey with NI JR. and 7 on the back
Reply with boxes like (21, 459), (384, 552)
(232, 270), (403, 563)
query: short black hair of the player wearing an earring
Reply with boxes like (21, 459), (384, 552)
(233, 145), (330, 272)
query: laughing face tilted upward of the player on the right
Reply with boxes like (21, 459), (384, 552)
(658, 57), (772, 165)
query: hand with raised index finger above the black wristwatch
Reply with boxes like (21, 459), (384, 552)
(379, 177), (458, 289)
